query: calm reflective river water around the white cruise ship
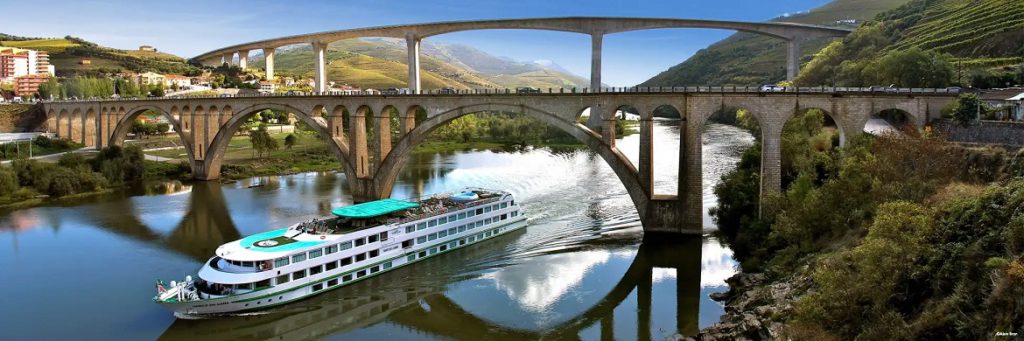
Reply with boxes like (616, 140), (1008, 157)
(0, 120), (753, 340)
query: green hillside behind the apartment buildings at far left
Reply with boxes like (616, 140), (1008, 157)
(0, 34), (199, 77)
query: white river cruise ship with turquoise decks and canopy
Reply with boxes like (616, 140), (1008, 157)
(154, 188), (526, 318)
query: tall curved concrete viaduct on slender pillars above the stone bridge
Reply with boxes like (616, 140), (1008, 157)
(193, 16), (851, 89)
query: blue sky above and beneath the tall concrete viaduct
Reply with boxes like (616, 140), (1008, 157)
(6, 0), (827, 86)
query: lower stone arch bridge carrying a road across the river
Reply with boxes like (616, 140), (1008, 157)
(42, 87), (956, 233)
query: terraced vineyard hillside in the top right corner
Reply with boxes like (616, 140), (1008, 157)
(796, 0), (1024, 87)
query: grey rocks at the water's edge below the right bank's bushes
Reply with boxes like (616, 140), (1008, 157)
(686, 268), (812, 341)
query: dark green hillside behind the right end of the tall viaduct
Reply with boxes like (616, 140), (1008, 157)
(640, 0), (908, 86)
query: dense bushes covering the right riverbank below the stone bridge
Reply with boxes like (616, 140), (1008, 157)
(698, 94), (1024, 340)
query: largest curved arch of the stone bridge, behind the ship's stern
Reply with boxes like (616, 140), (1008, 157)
(373, 102), (648, 217)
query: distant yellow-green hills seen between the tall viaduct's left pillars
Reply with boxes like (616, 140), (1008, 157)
(250, 39), (588, 89)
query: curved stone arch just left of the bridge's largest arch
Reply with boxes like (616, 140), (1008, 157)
(196, 102), (352, 179)
